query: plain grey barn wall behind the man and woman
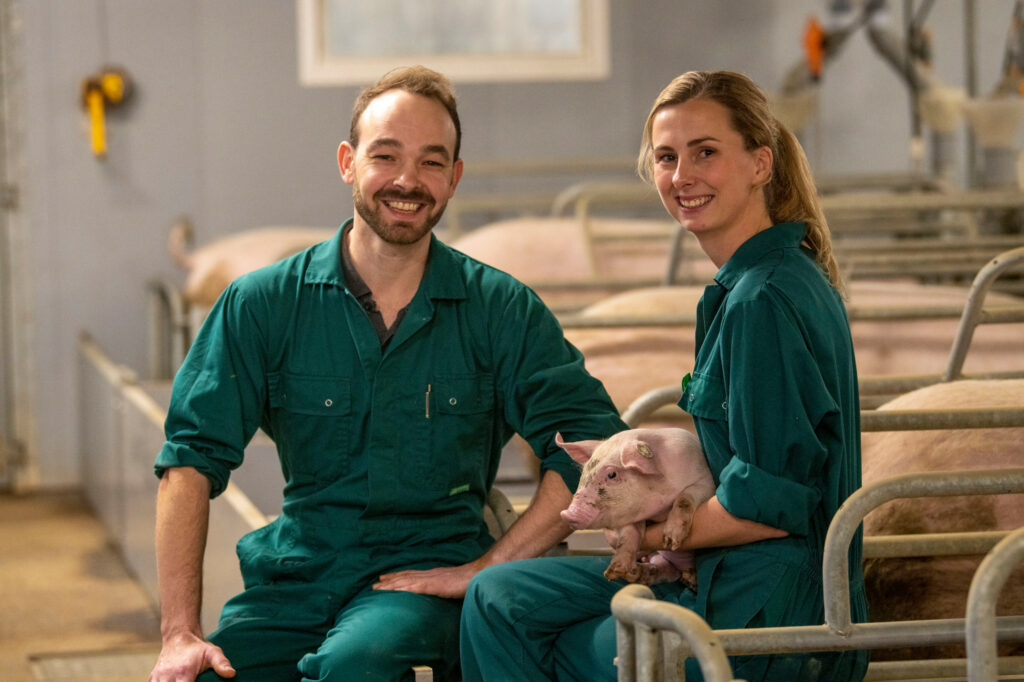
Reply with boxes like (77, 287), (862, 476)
(6, 0), (1013, 486)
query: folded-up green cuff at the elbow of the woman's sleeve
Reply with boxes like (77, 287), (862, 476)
(716, 457), (820, 536)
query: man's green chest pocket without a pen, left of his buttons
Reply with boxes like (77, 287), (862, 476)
(268, 372), (352, 485)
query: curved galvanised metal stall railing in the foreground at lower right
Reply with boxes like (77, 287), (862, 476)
(612, 469), (1024, 682)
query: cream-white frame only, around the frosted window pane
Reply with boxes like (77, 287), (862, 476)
(296, 0), (610, 87)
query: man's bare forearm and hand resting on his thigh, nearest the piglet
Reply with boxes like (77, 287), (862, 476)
(374, 471), (572, 599)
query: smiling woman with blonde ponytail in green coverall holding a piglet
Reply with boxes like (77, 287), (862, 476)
(462, 72), (867, 682)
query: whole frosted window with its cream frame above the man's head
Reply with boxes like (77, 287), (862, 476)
(297, 0), (608, 85)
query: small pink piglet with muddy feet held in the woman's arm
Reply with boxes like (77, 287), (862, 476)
(555, 428), (715, 588)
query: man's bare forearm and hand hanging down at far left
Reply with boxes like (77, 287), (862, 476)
(150, 467), (234, 682)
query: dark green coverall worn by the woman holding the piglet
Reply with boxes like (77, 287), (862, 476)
(461, 223), (867, 682)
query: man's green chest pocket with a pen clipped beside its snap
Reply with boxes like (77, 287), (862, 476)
(430, 374), (496, 494)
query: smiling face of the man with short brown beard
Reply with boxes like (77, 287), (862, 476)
(338, 90), (462, 245)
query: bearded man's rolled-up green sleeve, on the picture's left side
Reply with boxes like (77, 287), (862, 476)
(154, 285), (266, 498)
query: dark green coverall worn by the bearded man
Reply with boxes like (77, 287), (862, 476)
(156, 223), (625, 682)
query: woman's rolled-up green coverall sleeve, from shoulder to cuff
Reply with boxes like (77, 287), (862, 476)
(717, 296), (839, 535)
